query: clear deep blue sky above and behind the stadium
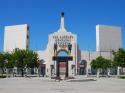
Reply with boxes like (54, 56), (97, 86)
(0, 0), (125, 51)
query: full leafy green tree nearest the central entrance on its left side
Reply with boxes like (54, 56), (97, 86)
(13, 49), (38, 77)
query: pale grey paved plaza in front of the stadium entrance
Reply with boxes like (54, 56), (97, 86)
(0, 77), (125, 93)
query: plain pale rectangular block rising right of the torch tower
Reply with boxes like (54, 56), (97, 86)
(96, 25), (122, 51)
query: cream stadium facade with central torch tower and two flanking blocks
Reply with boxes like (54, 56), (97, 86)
(4, 13), (122, 78)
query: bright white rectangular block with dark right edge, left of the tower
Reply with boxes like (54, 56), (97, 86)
(4, 24), (29, 52)
